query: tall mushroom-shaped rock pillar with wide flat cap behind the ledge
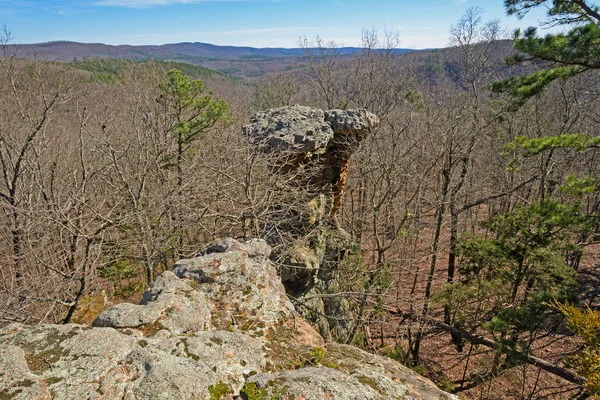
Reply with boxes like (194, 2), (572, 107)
(243, 105), (379, 342)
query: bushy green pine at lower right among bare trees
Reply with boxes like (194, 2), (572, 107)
(443, 200), (586, 372)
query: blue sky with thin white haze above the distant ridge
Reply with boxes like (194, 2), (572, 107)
(0, 0), (543, 49)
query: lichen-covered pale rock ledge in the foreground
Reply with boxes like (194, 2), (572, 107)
(0, 239), (456, 400)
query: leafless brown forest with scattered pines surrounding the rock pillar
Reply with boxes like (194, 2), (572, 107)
(0, 0), (600, 399)
